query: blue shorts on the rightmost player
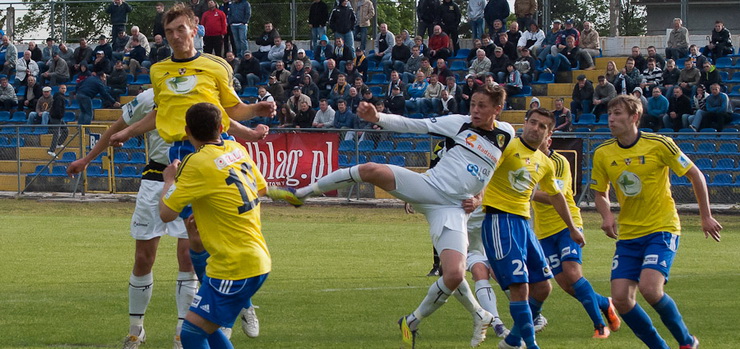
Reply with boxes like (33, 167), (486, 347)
(612, 231), (680, 282)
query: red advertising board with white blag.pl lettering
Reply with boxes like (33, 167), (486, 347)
(238, 133), (339, 187)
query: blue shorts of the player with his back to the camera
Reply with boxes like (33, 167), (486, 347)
(190, 273), (269, 327)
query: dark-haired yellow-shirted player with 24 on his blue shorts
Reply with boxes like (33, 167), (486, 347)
(481, 108), (584, 349)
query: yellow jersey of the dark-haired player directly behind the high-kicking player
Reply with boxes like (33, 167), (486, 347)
(483, 137), (560, 219)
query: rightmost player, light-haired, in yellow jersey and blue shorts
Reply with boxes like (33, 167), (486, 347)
(591, 96), (722, 349)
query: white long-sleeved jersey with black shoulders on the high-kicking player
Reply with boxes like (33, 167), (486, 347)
(377, 113), (515, 200)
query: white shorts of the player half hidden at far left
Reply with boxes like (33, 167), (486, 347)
(131, 179), (188, 240)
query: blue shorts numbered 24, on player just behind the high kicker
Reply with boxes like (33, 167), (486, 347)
(481, 213), (552, 290)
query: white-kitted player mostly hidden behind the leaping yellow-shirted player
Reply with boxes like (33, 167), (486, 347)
(67, 89), (269, 348)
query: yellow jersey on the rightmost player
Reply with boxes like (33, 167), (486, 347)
(591, 132), (694, 240)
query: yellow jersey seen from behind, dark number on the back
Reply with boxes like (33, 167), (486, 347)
(163, 141), (272, 280)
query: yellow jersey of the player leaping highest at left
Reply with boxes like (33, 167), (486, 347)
(150, 53), (241, 143)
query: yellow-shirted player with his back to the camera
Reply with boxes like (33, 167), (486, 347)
(159, 103), (272, 349)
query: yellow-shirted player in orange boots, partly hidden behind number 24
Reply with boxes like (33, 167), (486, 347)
(532, 137), (621, 339)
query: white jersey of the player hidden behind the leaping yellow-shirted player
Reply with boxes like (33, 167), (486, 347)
(122, 88), (172, 165)
